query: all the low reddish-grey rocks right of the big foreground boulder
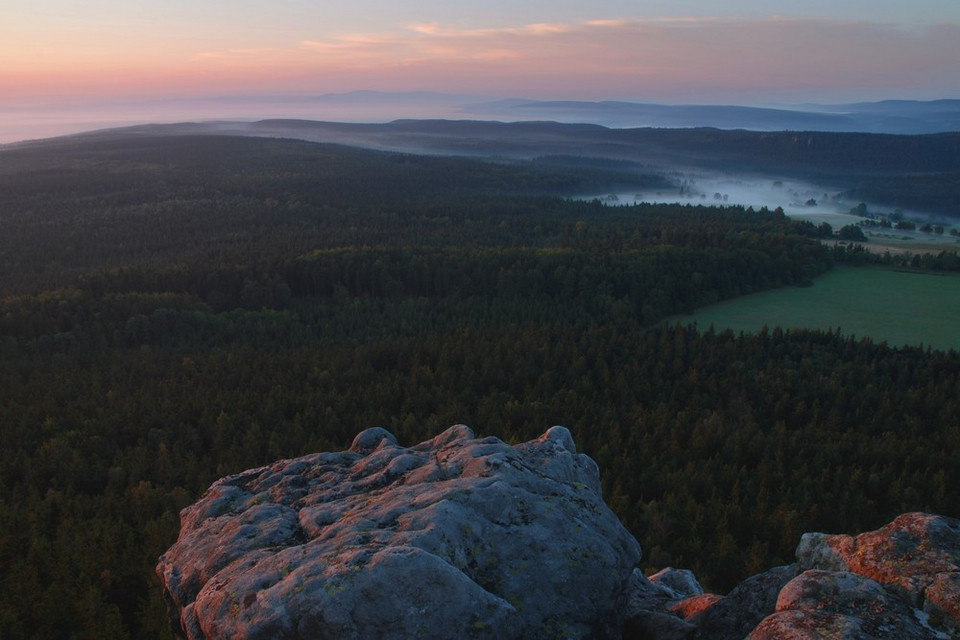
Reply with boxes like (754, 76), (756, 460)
(623, 513), (960, 640)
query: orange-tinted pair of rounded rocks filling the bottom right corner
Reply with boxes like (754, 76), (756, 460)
(750, 513), (960, 640)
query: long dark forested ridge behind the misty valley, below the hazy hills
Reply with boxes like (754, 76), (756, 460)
(79, 120), (960, 216)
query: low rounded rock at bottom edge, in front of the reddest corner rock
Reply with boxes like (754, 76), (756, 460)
(749, 569), (937, 640)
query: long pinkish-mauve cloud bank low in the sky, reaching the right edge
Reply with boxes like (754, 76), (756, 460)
(231, 19), (960, 97)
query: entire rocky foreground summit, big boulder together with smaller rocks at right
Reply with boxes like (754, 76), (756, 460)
(157, 425), (960, 640)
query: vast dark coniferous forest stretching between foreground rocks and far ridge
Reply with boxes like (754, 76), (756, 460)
(0, 134), (960, 639)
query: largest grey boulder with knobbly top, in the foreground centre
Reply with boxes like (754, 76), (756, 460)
(157, 425), (640, 639)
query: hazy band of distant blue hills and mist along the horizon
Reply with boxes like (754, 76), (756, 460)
(0, 91), (960, 144)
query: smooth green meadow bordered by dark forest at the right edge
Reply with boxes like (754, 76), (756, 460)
(682, 267), (960, 350)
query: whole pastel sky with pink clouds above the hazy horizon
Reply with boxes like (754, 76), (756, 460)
(0, 0), (960, 104)
